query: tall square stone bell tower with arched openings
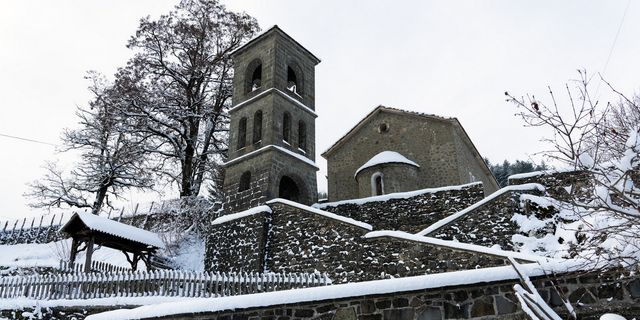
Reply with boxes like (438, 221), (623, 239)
(223, 26), (320, 213)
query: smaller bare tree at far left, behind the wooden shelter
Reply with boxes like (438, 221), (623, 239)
(26, 72), (153, 214)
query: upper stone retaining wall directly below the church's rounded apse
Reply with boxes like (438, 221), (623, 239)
(317, 183), (484, 233)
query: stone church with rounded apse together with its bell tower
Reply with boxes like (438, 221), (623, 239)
(223, 26), (498, 213)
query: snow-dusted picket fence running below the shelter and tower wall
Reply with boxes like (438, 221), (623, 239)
(0, 270), (331, 300)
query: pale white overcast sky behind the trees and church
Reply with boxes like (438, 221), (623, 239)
(0, 0), (640, 219)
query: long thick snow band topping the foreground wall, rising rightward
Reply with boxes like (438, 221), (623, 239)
(86, 260), (584, 320)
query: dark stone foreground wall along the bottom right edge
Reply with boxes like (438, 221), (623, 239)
(150, 273), (640, 320)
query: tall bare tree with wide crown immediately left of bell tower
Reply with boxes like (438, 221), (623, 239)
(116, 0), (258, 197)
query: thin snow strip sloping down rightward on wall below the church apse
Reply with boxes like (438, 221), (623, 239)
(364, 230), (550, 262)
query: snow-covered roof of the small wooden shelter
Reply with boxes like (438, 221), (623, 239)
(60, 212), (164, 249)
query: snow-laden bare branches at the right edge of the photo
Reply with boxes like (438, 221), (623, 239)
(505, 71), (640, 266)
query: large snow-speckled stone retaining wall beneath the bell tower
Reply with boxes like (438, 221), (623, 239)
(205, 203), (508, 283)
